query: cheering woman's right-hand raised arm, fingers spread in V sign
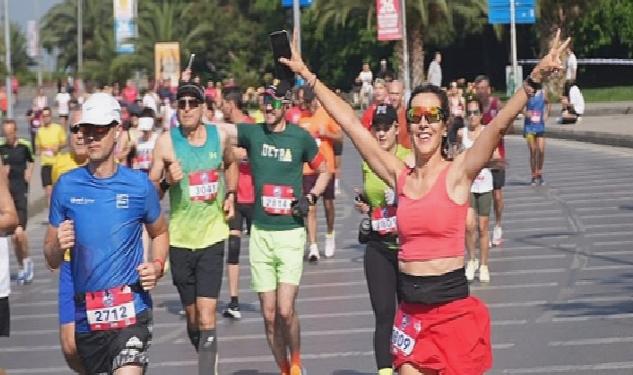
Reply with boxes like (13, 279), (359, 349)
(463, 30), (571, 180)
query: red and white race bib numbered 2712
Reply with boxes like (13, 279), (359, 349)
(86, 286), (136, 331)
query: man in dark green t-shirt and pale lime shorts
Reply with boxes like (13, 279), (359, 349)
(220, 87), (331, 375)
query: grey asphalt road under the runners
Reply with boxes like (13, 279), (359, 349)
(0, 136), (633, 375)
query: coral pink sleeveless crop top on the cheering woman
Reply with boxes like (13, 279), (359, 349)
(396, 165), (468, 261)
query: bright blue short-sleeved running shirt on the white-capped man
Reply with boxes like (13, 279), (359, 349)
(48, 165), (160, 332)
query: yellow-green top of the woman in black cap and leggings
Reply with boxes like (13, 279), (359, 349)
(363, 145), (411, 249)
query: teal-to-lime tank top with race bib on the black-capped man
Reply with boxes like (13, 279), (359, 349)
(169, 125), (229, 250)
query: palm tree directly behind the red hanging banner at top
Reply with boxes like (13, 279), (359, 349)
(314, 0), (486, 86)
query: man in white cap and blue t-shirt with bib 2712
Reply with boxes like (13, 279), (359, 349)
(44, 93), (169, 375)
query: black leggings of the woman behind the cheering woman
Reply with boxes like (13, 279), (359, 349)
(365, 240), (398, 369)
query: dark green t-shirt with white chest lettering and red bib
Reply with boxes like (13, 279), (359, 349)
(237, 124), (319, 230)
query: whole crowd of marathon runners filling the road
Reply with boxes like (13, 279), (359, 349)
(0, 30), (569, 375)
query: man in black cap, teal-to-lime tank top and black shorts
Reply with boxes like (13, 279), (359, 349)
(150, 70), (238, 375)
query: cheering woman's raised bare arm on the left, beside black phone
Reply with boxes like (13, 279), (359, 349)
(279, 33), (405, 187)
